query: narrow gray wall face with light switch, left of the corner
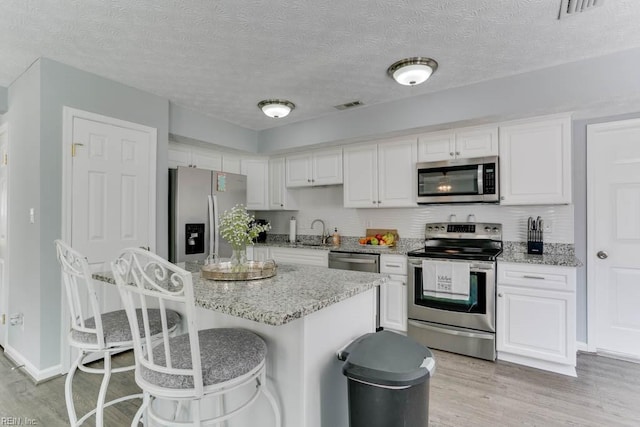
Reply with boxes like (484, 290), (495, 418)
(7, 62), (42, 368)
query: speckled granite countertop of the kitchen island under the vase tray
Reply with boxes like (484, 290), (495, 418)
(93, 264), (388, 326)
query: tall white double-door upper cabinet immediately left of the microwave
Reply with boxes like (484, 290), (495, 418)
(343, 137), (417, 208)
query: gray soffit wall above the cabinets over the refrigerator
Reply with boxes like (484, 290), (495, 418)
(169, 104), (258, 153)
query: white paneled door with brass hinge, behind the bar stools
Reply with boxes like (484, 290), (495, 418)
(71, 110), (156, 310)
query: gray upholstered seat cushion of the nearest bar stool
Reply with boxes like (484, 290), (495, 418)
(140, 328), (267, 389)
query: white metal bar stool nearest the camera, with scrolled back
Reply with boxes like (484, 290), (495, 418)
(111, 248), (281, 427)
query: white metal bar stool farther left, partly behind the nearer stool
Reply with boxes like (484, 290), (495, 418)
(55, 240), (181, 427)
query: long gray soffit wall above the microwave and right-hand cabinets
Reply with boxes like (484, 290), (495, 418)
(258, 49), (640, 153)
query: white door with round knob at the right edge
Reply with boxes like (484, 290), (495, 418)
(587, 120), (640, 360)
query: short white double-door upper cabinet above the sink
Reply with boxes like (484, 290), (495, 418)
(286, 148), (342, 187)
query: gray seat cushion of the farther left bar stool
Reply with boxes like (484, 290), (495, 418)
(71, 309), (181, 347)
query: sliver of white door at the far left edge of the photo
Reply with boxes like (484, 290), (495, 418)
(0, 123), (9, 348)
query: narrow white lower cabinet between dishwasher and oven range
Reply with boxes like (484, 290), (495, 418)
(380, 254), (407, 333)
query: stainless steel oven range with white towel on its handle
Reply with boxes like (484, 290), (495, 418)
(407, 223), (502, 360)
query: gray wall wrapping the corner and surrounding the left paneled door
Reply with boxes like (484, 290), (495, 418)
(9, 59), (169, 370)
